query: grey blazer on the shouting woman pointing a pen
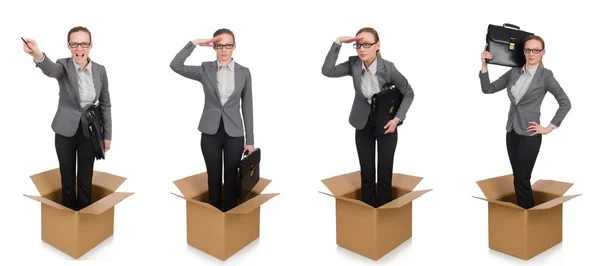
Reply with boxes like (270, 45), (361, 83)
(36, 54), (112, 140)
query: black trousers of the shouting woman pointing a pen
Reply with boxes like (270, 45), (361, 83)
(54, 123), (96, 211)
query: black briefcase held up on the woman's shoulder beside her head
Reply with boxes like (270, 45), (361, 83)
(485, 23), (533, 67)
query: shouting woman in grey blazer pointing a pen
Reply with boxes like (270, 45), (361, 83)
(23, 27), (112, 210)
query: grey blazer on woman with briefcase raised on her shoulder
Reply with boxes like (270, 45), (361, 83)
(479, 66), (571, 136)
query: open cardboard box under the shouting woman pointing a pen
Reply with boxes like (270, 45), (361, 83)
(24, 169), (133, 259)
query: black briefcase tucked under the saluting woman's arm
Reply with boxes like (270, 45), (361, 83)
(370, 83), (403, 136)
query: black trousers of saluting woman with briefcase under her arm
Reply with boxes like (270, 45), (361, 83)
(355, 114), (398, 208)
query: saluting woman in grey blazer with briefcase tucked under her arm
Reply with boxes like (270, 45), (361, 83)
(321, 28), (414, 208)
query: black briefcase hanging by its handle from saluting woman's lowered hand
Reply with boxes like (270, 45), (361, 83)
(236, 148), (260, 200)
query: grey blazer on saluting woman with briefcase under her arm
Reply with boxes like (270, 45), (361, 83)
(321, 42), (415, 130)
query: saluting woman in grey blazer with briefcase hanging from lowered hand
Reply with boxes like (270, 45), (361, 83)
(171, 29), (254, 212)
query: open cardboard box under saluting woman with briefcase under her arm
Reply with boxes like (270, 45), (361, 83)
(320, 171), (431, 260)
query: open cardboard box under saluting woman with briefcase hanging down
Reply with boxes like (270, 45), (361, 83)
(171, 172), (279, 261)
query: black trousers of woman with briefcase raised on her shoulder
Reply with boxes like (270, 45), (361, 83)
(506, 130), (542, 209)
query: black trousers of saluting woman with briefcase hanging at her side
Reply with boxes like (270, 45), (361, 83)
(200, 120), (244, 212)
